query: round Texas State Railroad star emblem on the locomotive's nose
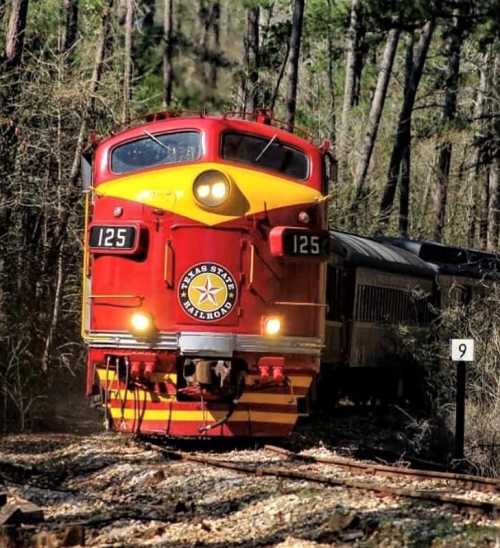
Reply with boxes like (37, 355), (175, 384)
(179, 263), (238, 322)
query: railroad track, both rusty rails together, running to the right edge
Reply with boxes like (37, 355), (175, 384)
(146, 443), (500, 516)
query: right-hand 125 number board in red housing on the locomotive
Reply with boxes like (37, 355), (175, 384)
(270, 227), (330, 259)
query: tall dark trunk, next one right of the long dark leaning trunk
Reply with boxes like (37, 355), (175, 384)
(434, 13), (463, 242)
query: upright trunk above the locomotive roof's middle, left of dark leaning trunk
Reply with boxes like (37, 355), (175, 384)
(242, 6), (260, 113)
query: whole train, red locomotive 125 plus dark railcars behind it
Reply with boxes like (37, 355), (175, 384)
(82, 112), (500, 436)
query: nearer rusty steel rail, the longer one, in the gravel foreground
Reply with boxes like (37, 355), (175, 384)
(147, 444), (500, 515)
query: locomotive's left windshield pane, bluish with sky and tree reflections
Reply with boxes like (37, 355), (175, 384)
(111, 131), (201, 173)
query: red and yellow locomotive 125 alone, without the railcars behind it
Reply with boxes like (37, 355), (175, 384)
(82, 112), (329, 436)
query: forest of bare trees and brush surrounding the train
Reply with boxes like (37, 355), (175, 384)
(0, 0), (500, 470)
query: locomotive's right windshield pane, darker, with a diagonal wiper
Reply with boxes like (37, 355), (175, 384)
(222, 133), (309, 180)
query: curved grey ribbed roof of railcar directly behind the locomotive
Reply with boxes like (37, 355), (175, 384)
(330, 231), (436, 278)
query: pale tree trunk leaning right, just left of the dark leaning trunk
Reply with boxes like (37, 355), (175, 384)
(351, 29), (400, 218)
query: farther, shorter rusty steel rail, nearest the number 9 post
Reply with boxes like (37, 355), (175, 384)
(264, 445), (500, 492)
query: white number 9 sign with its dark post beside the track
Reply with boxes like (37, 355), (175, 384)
(450, 339), (474, 459)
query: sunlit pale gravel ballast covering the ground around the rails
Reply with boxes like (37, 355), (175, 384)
(0, 434), (500, 548)
